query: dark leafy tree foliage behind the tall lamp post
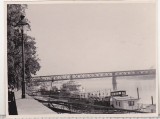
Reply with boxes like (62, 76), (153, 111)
(7, 4), (40, 88)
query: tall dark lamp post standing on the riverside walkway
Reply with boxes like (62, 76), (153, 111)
(16, 15), (29, 98)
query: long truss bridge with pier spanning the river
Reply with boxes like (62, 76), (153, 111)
(31, 69), (156, 90)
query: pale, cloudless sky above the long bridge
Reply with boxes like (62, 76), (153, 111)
(26, 3), (156, 76)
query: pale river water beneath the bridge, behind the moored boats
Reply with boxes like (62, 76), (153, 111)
(77, 76), (156, 104)
